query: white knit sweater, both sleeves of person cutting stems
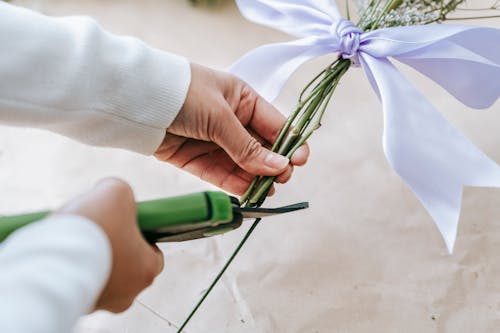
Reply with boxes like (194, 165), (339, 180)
(0, 1), (191, 333)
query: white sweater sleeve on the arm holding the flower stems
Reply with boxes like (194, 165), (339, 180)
(0, 1), (191, 154)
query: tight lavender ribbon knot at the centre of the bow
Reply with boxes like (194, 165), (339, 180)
(330, 18), (363, 66)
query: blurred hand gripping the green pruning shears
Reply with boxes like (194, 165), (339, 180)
(56, 179), (163, 313)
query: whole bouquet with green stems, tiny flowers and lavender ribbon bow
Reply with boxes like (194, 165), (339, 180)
(179, 0), (500, 332)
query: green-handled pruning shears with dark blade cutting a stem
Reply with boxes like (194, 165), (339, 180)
(0, 192), (309, 243)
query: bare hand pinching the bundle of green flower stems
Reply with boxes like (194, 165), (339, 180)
(155, 64), (309, 195)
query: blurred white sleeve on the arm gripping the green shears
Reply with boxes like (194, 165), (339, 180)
(0, 215), (111, 333)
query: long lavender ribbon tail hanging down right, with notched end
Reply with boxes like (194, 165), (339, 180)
(360, 53), (500, 253)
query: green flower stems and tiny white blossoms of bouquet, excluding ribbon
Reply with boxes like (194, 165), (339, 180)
(177, 0), (500, 333)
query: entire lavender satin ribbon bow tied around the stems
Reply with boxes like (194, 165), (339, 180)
(230, 0), (500, 249)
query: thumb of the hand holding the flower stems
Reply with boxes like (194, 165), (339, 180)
(214, 111), (290, 176)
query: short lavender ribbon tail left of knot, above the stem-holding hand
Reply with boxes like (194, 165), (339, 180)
(229, 38), (334, 101)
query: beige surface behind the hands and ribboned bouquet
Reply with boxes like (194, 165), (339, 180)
(0, 0), (500, 333)
